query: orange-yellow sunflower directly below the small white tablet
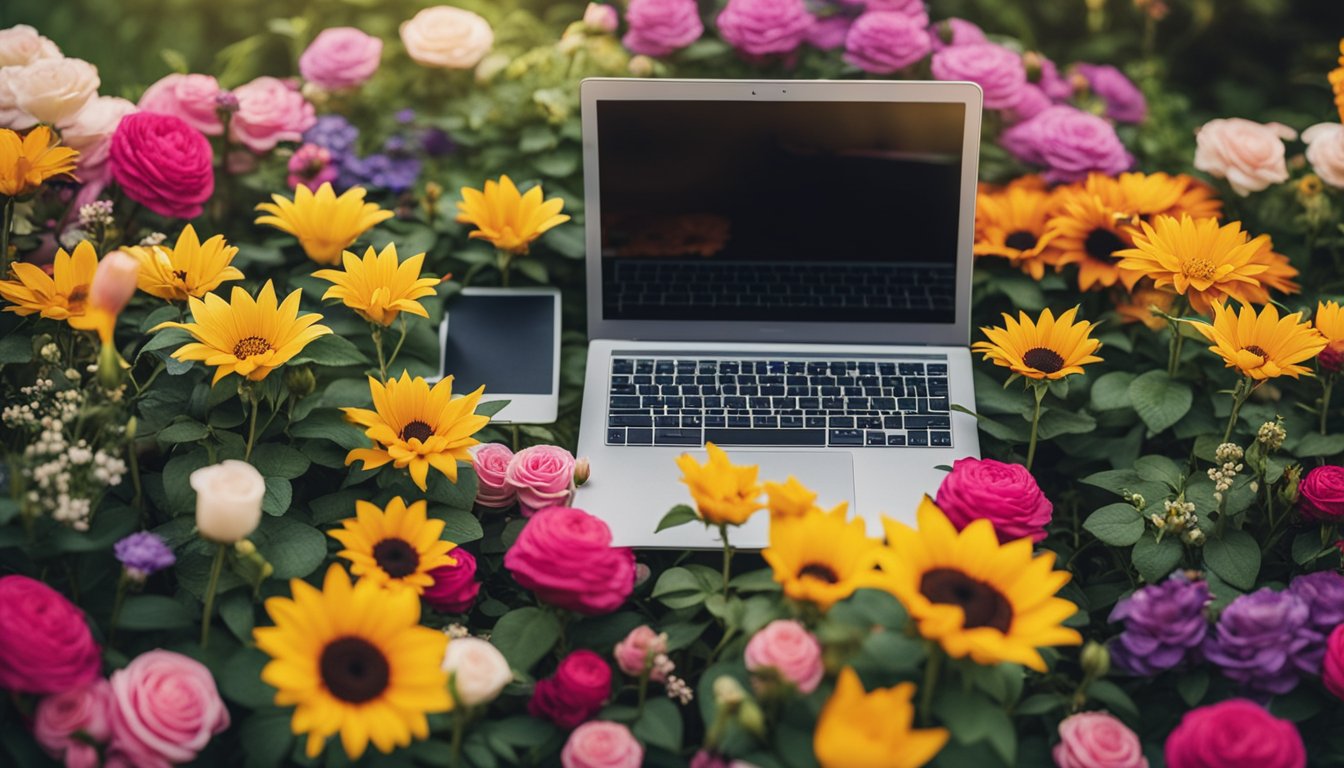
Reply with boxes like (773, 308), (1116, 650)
(341, 371), (491, 491)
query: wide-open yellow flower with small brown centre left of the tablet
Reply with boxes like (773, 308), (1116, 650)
(151, 280), (332, 385)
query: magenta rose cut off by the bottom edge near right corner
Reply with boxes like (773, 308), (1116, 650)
(1165, 698), (1306, 768)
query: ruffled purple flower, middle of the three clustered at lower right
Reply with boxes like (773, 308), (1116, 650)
(1204, 586), (1310, 694)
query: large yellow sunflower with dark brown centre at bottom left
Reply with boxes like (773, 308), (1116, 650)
(253, 565), (453, 760)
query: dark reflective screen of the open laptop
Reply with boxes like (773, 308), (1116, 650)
(595, 100), (966, 324)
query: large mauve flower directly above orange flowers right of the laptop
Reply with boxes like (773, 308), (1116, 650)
(999, 104), (1134, 182)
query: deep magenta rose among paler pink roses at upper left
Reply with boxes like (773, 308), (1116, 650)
(108, 112), (215, 219)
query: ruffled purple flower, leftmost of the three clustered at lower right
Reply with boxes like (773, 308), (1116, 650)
(1110, 573), (1212, 677)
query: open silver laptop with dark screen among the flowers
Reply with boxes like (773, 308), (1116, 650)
(575, 79), (981, 549)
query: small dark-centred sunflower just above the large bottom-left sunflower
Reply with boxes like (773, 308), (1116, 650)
(328, 496), (457, 594)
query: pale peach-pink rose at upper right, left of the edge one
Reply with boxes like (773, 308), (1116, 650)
(1195, 117), (1297, 198)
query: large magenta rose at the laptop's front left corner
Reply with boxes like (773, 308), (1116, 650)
(504, 507), (634, 616)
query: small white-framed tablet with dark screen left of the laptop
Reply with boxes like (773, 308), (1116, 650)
(435, 288), (560, 424)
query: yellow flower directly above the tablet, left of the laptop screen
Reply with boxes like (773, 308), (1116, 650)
(457, 176), (570, 253)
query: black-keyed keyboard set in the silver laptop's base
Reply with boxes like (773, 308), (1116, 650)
(606, 355), (952, 448)
